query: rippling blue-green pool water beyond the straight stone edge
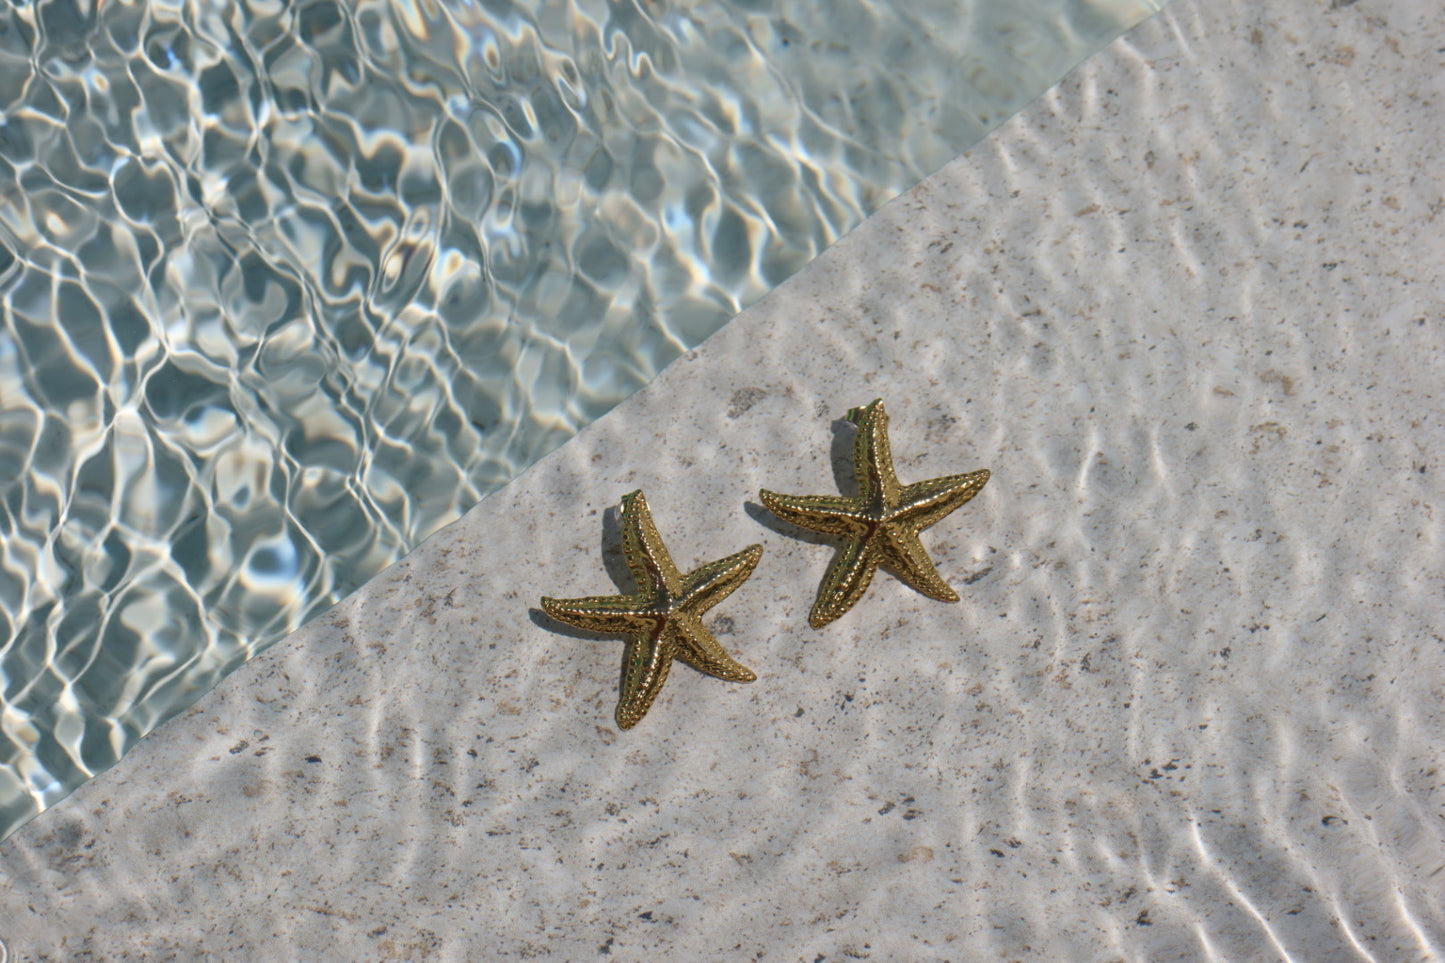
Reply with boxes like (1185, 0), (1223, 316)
(0, 0), (1159, 836)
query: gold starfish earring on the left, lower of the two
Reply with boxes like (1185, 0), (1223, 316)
(542, 492), (763, 729)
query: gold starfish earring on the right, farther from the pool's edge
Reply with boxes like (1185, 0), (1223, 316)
(760, 399), (988, 629)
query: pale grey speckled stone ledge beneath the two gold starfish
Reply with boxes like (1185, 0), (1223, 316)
(0, 0), (1445, 963)
